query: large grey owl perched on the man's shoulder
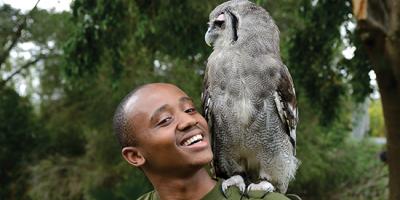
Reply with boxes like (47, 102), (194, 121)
(202, 0), (298, 193)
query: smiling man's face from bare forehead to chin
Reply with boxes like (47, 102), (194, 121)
(126, 84), (212, 175)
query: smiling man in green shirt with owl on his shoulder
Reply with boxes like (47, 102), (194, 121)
(114, 83), (287, 200)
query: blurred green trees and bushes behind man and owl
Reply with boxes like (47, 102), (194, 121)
(0, 0), (389, 200)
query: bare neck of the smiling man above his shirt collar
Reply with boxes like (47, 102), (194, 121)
(149, 168), (216, 200)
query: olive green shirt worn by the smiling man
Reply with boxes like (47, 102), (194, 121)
(137, 180), (290, 200)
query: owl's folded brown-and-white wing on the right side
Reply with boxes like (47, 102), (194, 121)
(274, 66), (299, 155)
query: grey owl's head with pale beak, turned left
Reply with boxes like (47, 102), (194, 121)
(205, 0), (279, 52)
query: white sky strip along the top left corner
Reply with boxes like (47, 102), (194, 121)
(0, 0), (72, 12)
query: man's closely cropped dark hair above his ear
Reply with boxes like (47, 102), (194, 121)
(113, 84), (148, 148)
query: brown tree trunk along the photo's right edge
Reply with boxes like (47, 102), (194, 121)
(353, 0), (400, 200)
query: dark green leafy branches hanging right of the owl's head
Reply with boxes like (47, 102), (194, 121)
(288, 0), (371, 124)
